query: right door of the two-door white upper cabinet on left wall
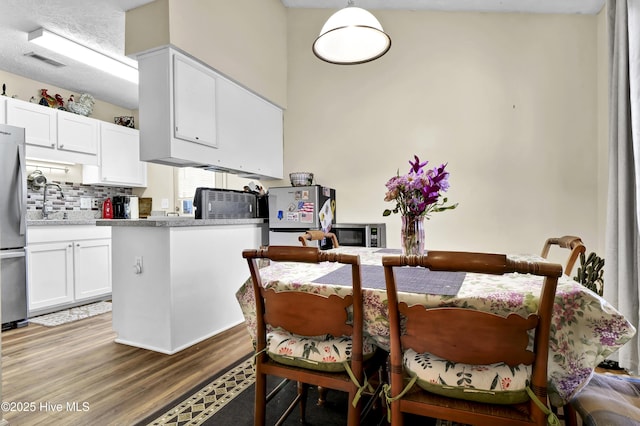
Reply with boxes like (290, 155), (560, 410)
(58, 111), (100, 155)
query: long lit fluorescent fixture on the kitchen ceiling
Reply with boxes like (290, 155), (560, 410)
(29, 28), (138, 84)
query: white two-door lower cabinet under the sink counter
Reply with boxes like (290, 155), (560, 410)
(27, 225), (111, 316)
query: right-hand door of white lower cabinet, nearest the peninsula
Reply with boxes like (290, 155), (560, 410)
(73, 239), (111, 301)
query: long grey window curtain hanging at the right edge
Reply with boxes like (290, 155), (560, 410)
(604, 0), (640, 374)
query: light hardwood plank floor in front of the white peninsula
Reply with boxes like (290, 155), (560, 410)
(2, 313), (253, 426)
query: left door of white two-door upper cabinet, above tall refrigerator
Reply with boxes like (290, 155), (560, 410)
(7, 99), (57, 150)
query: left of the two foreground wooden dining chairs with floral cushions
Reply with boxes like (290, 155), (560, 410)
(242, 246), (386, 426)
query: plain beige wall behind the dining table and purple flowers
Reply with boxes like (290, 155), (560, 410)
(278, 9), (602, 252)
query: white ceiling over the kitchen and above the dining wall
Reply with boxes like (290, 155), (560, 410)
(0, 0), (605, 109)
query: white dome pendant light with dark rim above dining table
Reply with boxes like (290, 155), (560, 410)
(313, 0), (391, 65)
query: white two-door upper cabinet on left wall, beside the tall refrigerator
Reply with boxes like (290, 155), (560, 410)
(6, 99), (99, 164)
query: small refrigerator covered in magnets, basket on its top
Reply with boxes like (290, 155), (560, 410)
(268, 185), (336, 249)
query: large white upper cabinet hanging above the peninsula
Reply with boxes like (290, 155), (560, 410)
(138, 47), (283, 179)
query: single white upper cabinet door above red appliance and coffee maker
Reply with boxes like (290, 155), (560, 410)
(100, 123), (147, 186)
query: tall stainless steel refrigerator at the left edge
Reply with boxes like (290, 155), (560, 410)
(0, 124), (27, 330)
